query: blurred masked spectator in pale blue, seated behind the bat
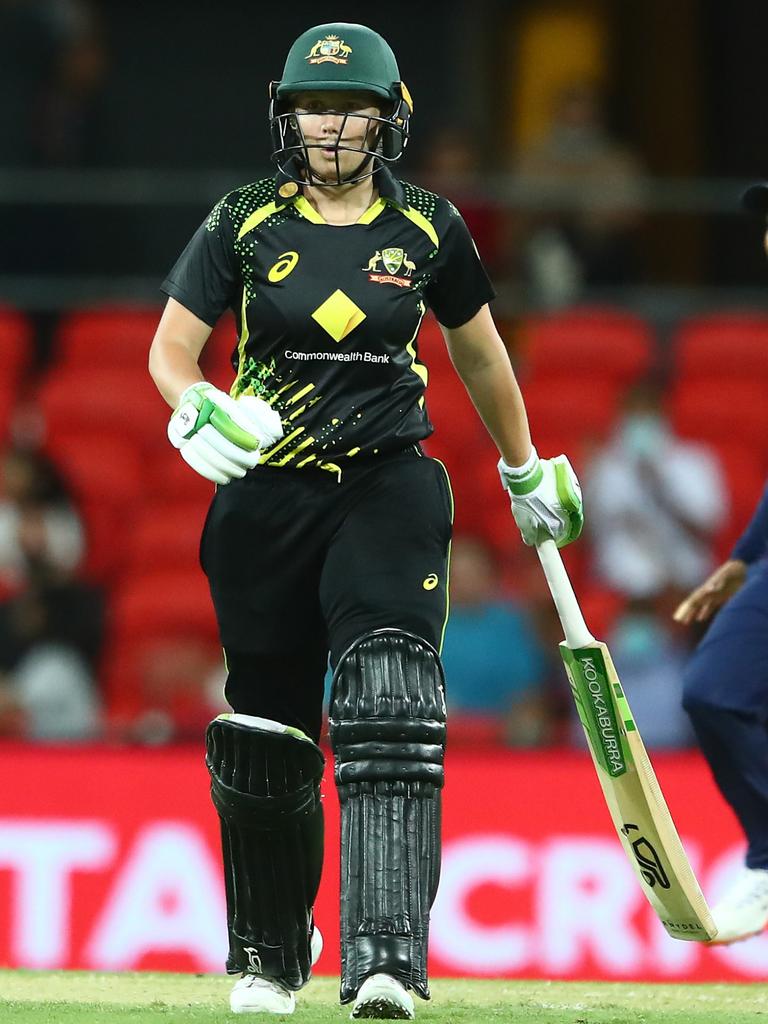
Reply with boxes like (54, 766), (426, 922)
(571, 590), (693, 750)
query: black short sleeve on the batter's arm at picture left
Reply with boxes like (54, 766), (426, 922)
(160, 199), (240, 327)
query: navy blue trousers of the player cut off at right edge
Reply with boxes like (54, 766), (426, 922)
(683, 563), (768, 868)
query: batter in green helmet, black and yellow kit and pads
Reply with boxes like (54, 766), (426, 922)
(150, 24), (582, 1019)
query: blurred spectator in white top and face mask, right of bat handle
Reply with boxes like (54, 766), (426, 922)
(585, 381), (727, 598)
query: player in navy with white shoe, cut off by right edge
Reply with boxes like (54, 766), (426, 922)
(675, 183), (768, 945)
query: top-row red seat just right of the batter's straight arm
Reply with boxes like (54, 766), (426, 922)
(521, 306), (655, 388)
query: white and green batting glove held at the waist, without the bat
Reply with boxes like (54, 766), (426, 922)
(168, 381), (283, 483)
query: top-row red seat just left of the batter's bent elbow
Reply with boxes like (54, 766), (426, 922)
(54, 306), (162, 373)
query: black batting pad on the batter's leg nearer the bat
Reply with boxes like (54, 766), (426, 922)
(330, 630), (445, 1002)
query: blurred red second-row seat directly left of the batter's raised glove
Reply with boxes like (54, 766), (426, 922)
(37, 367), (169, 449)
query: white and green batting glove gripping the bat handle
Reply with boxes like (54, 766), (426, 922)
(499, 449), (584, 548)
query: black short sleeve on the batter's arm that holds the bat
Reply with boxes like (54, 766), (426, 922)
(424, 200), (496, 328)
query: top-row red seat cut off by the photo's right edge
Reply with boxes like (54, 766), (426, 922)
(673, 312), (768, 381)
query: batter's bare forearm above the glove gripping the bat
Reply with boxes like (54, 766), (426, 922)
(456, 352), (531, 466)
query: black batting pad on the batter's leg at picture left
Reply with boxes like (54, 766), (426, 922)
(206, 715), (325, 989)
